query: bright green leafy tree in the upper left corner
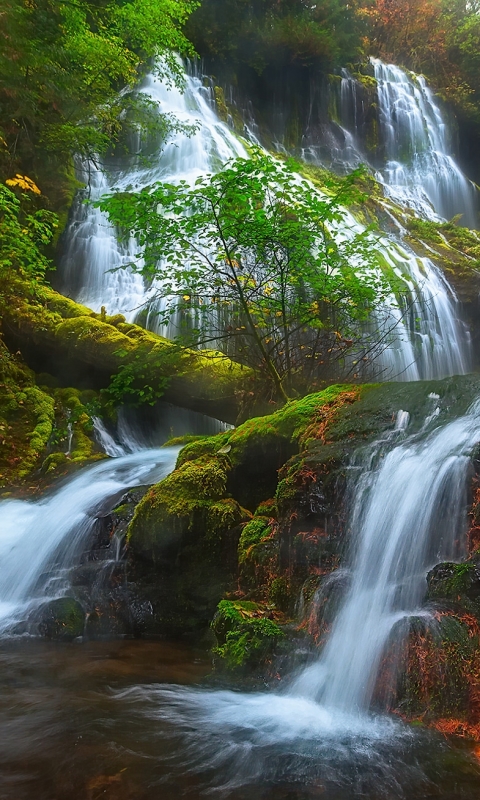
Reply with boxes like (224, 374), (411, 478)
(0, 0), (197, 189)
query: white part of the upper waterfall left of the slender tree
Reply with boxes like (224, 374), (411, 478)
(60, 63), (247, 321)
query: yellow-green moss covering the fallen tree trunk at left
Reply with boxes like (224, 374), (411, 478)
(1, 275), (254, 421)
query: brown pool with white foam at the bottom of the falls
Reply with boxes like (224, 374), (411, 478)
(0, 639), (480, 800)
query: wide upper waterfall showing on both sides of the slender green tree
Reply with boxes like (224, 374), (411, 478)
(61, 57), (470, 380)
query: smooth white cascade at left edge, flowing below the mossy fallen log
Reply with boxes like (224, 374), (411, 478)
(0, 447), (179, 632)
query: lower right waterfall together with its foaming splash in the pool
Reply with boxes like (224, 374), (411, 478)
(110, 395), (480, 799)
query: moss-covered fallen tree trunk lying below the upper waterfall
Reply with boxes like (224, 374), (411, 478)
(2, 278), (258, 423)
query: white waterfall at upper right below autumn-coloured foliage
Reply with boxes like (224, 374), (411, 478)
(371, 58), (478, 228)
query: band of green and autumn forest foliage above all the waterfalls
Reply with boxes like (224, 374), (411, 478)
(0, 0), (480, 207)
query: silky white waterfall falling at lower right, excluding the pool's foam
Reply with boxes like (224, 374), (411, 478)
(292, 402), (480, 713)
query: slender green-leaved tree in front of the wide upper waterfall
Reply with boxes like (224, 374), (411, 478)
(98, 151), (391, 399)
